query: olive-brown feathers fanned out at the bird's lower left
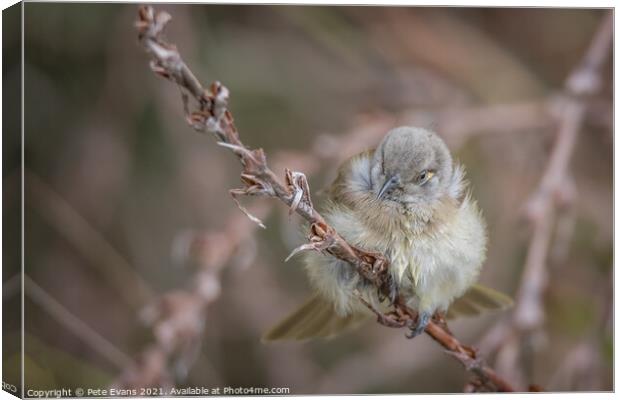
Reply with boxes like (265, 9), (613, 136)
(262, 294), (368, 342)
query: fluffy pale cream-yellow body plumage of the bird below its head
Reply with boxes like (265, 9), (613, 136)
(306, 151), (487, 315)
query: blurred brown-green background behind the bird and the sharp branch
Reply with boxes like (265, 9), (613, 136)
(3, 3), (613, 394)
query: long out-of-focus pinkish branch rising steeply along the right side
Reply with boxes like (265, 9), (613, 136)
(480, 12), (613, 387)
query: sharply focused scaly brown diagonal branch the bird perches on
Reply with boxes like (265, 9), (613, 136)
(136, 6), (513, 391)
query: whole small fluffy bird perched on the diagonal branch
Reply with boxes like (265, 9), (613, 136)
(263, 127), (511, 341)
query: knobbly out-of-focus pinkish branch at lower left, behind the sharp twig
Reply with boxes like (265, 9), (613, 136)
(113, 205), (268, 388)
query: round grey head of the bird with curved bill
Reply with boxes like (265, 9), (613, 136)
(370, 127), (453, 207)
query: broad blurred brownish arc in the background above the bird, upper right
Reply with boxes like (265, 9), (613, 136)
(357, 7), (544, 103)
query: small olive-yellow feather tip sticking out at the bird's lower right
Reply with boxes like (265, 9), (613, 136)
(446, 285), (514, 319)
